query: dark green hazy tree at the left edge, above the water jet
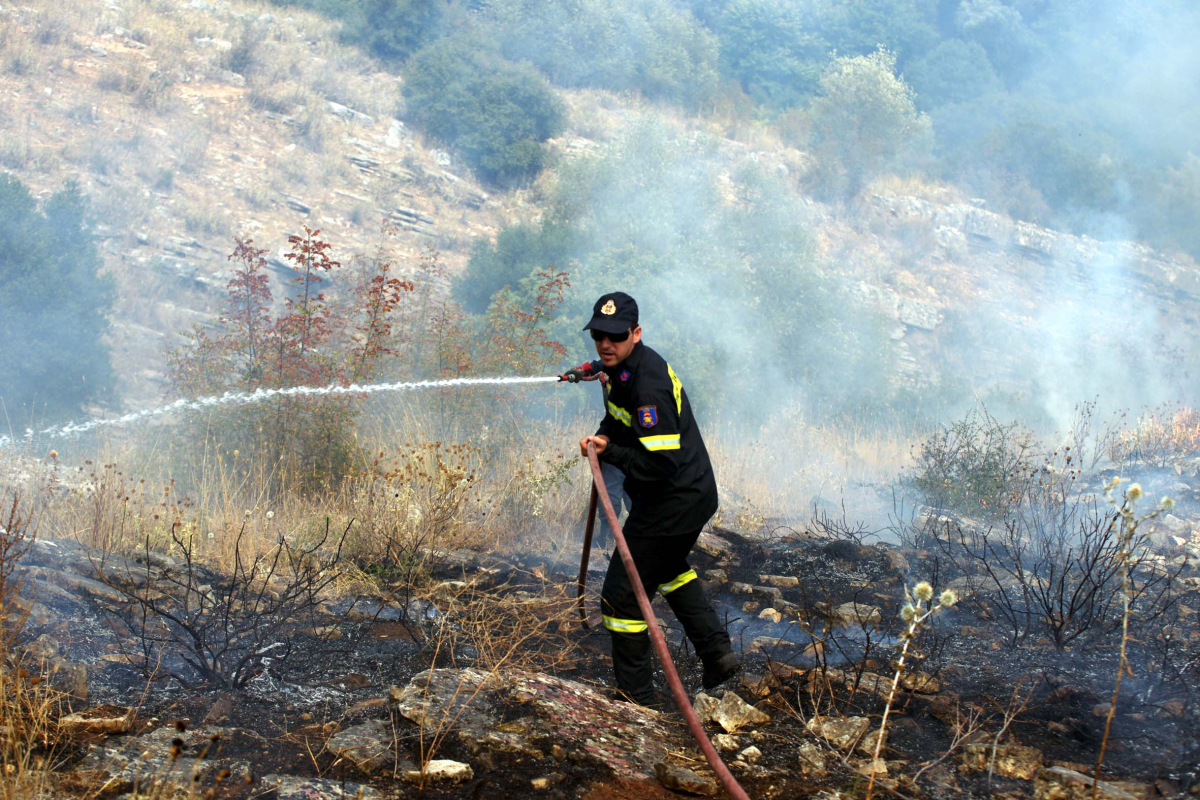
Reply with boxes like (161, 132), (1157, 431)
(0, 175), (114, 425)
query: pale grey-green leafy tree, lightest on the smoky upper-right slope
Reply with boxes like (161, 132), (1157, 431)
(810, 49), (932, 197)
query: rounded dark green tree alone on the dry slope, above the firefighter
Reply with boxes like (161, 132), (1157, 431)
(404, 38), (565, 186)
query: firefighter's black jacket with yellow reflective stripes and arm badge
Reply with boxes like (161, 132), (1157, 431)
(596, 343), (718, 536)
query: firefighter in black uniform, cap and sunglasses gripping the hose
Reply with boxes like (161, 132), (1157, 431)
(580, 291), (740, 705)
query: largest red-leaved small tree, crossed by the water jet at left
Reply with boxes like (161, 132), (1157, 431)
(167, 225), (414, 486)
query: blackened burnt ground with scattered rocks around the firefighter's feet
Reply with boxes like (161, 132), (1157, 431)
(11, 510), (1200, 800)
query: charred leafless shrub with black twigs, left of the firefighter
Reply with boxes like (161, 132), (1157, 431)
(95, 519), (349, 688)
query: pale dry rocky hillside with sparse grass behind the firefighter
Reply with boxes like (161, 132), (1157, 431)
(0, 0), (1198, 422)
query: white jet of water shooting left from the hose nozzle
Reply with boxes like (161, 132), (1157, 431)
(0, 375), (566, 450)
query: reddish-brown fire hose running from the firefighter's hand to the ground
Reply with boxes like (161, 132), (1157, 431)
(578, 443), (750, 800)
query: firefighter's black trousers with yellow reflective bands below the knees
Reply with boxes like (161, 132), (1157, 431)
(600, 530), (732, 704)
